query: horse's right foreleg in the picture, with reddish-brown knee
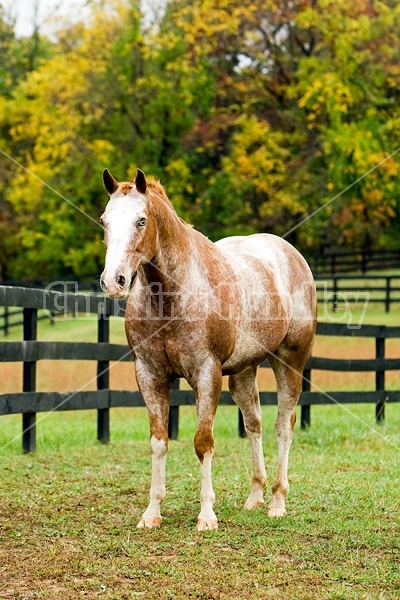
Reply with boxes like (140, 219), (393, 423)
(192, 365), (222, 531)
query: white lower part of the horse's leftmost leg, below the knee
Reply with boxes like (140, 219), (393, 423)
(138, 436), (167, 529)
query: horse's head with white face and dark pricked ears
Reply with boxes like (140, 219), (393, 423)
(100, 169), (156, 298)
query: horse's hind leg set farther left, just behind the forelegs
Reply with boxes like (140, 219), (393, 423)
(229, 368), (267, 510)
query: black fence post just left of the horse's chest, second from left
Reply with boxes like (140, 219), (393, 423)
(97, 305), (110, 444)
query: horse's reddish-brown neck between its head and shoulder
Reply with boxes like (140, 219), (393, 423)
(144, 192), (196, 292)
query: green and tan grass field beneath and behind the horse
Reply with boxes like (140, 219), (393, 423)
(0, 306), (400, 600)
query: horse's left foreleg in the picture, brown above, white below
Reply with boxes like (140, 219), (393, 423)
(136, 358), (170, 529)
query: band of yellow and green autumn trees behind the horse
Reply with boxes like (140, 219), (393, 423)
(0, 0), (400, 279)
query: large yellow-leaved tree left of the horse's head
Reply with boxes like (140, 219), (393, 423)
(1, 1), (145, 277)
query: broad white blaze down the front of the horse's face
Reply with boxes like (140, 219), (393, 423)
(102, 191), (147, 290)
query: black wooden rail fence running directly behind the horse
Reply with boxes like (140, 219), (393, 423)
(0, 286), (400, 452)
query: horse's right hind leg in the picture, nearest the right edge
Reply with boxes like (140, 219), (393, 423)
(268, 351), (304, 517)
